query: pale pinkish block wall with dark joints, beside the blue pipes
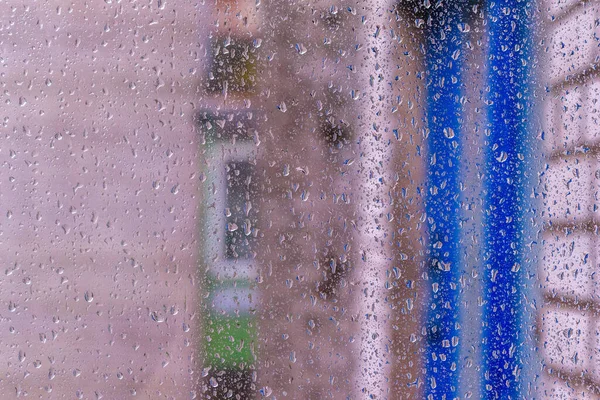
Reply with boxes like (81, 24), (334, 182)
(538, 0), (600, 399)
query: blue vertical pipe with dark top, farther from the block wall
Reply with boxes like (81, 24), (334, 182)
(424, 1), (465, 399)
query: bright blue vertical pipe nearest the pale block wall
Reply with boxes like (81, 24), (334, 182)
(482, 0), (532, 399)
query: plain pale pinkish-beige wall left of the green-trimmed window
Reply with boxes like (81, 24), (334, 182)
(0, 1), (202, 399)
